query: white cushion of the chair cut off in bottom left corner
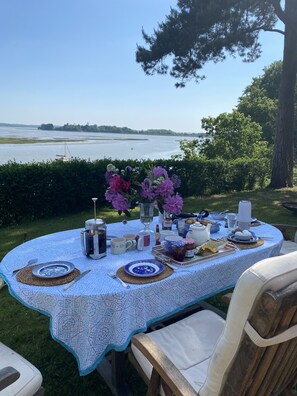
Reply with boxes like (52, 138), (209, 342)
(0, 342), (42, 396)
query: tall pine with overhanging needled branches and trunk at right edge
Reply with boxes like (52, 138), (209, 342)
(136, 0), (297, 187)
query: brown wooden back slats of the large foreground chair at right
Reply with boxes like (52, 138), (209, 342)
(220, 282), (297, 396)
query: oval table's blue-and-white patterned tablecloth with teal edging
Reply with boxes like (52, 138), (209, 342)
(0, 218), (283, 394)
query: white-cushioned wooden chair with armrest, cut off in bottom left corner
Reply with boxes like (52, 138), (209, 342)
(0, 342), (44, 396)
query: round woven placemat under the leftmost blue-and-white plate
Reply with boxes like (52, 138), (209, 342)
(16, 265), (80, 286)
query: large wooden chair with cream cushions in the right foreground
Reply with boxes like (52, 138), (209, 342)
(130, 252), (297, 396)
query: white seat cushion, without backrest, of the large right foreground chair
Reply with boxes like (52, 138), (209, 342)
(132, 310), (225, 392)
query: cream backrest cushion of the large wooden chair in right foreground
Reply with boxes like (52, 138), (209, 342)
(200, 252), (297, 396)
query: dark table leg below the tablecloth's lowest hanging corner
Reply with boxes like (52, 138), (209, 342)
(97, 350), (132, 396)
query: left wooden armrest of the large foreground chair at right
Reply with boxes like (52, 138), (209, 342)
(131, 333), (197, 396)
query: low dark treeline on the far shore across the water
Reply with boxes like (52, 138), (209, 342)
(38, 123), (204, 136)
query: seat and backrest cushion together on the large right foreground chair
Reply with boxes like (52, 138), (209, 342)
(132, 252), (297, 396)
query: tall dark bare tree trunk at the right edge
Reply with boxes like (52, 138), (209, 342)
(269, 0), (297, 188)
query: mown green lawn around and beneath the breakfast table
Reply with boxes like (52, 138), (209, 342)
(0, 188), (297, 396)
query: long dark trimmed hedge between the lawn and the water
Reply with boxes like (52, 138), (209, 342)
(0, 159), (270, 225)
